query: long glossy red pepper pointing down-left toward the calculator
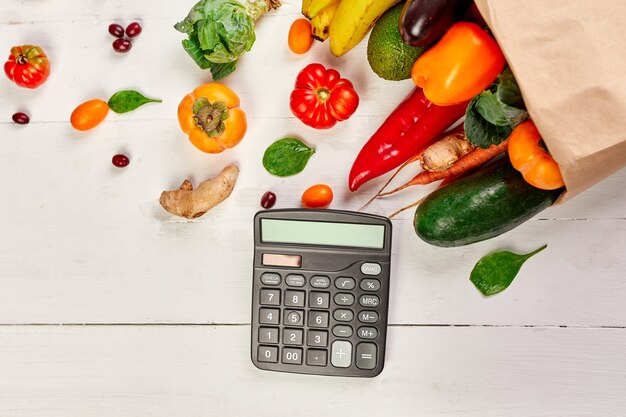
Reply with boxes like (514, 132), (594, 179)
(348, 88), (468, 191)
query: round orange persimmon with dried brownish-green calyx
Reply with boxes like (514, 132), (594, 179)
(178, 83), (248, 153)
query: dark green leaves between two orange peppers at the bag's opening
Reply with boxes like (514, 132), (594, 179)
(464, 68), (528, 149)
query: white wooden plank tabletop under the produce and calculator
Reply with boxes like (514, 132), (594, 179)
(0, 0), (626, 417)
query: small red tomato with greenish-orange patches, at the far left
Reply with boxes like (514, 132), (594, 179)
(4, 45), (50, 88)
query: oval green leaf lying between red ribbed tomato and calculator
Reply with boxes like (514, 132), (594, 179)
(263, 138), (315, 177)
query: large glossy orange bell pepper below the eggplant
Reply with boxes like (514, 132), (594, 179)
(411, 22), (506, 106)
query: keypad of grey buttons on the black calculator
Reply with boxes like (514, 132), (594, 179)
(252, 263), (386, 373)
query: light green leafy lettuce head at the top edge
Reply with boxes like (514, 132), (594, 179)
(174, 0), (280, 80)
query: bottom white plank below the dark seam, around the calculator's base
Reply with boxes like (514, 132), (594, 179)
(0, 326), (626, 417)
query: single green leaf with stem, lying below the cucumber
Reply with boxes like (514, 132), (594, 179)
(470, 245), (548, 296)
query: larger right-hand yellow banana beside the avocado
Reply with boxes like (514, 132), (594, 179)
(329, 0), (398, 56)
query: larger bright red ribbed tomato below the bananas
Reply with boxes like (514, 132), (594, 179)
(289, 64), (359, 129)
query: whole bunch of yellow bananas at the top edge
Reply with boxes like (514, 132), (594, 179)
(302, 0), (398, 56)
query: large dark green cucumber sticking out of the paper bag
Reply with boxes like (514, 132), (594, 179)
(413, 157), (563, 247)
